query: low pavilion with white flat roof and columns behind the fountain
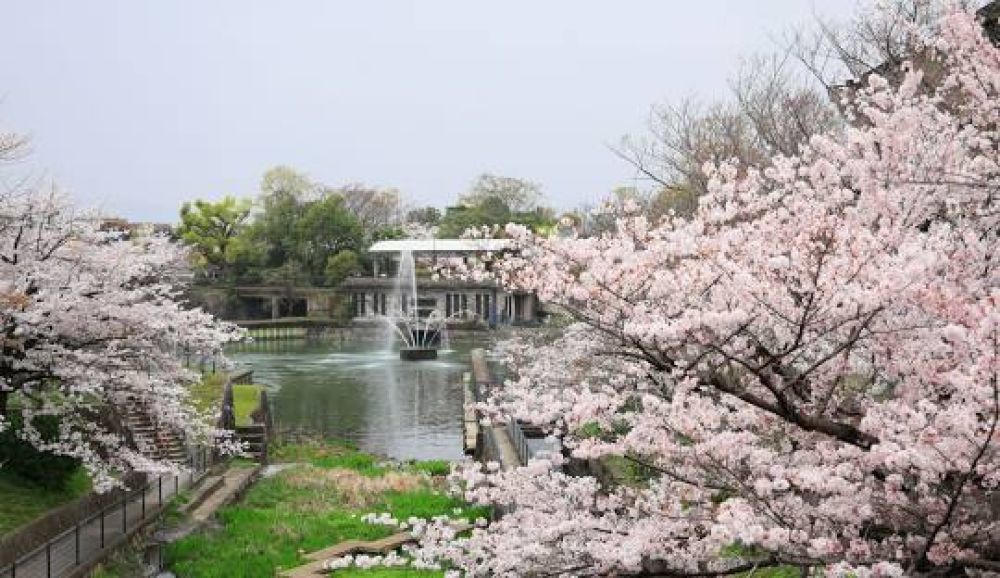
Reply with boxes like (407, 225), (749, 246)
(340, 239), (541, 326)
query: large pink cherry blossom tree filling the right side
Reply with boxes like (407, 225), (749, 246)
(408, 3), (1000, 577)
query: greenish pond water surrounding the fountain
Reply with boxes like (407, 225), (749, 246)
(229, 340), (492, 459)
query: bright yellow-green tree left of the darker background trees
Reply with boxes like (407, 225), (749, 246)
(177, 196), (250, 277)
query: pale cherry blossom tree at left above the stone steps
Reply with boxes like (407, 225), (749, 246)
(0, 178), (238, 489)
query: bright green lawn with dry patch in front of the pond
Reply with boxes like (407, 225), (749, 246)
(166, 444), (487, 578)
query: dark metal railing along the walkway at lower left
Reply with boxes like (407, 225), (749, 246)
(0, 450), (211, 578)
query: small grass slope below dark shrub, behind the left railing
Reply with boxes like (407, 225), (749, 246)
(0, 468), (91, 536)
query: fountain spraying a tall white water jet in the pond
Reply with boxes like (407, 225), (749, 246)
(382, 251), (447, 361)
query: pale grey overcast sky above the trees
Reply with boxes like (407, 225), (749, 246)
(0, 0), (855, 221)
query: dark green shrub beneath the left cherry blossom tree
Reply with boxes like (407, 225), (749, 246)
(0, 411), (80, 492)
